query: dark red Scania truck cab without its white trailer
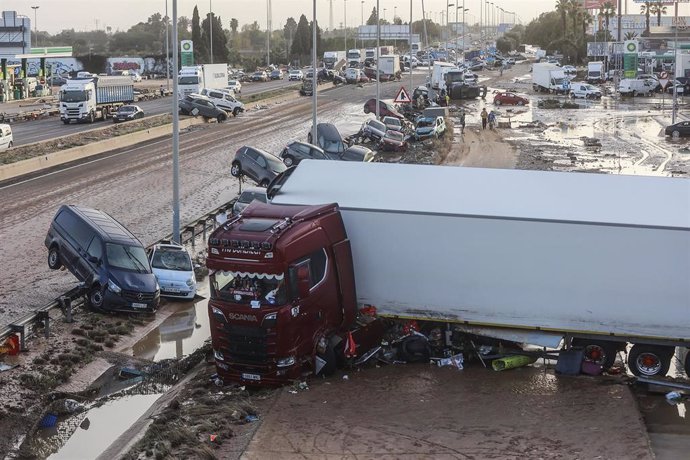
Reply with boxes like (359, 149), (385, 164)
(206, 202), (376, 385)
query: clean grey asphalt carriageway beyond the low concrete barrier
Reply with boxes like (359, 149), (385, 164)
(12, 80), (295, 146)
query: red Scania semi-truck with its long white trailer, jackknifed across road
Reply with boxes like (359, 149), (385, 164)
(207, 160), (690, 384)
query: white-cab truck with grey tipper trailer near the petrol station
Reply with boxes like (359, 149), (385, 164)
(59, 76), (134, 124)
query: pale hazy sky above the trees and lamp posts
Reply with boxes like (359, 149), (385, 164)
(0, 0), (556, 34)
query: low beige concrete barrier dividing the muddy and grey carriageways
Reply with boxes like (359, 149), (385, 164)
(0, 118), (205, 181)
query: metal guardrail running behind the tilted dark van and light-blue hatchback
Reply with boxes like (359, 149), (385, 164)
(0, 196), (236, 351)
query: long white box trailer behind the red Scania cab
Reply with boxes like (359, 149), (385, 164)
(268, 160), (690, 376)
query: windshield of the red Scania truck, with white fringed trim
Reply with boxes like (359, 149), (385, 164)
(209, 270), (287, 305)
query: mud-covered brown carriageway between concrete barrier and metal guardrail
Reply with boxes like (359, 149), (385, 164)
(0, 76), (424, 324)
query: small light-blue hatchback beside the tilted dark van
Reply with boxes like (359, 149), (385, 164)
(149, 242), (196, 300)
